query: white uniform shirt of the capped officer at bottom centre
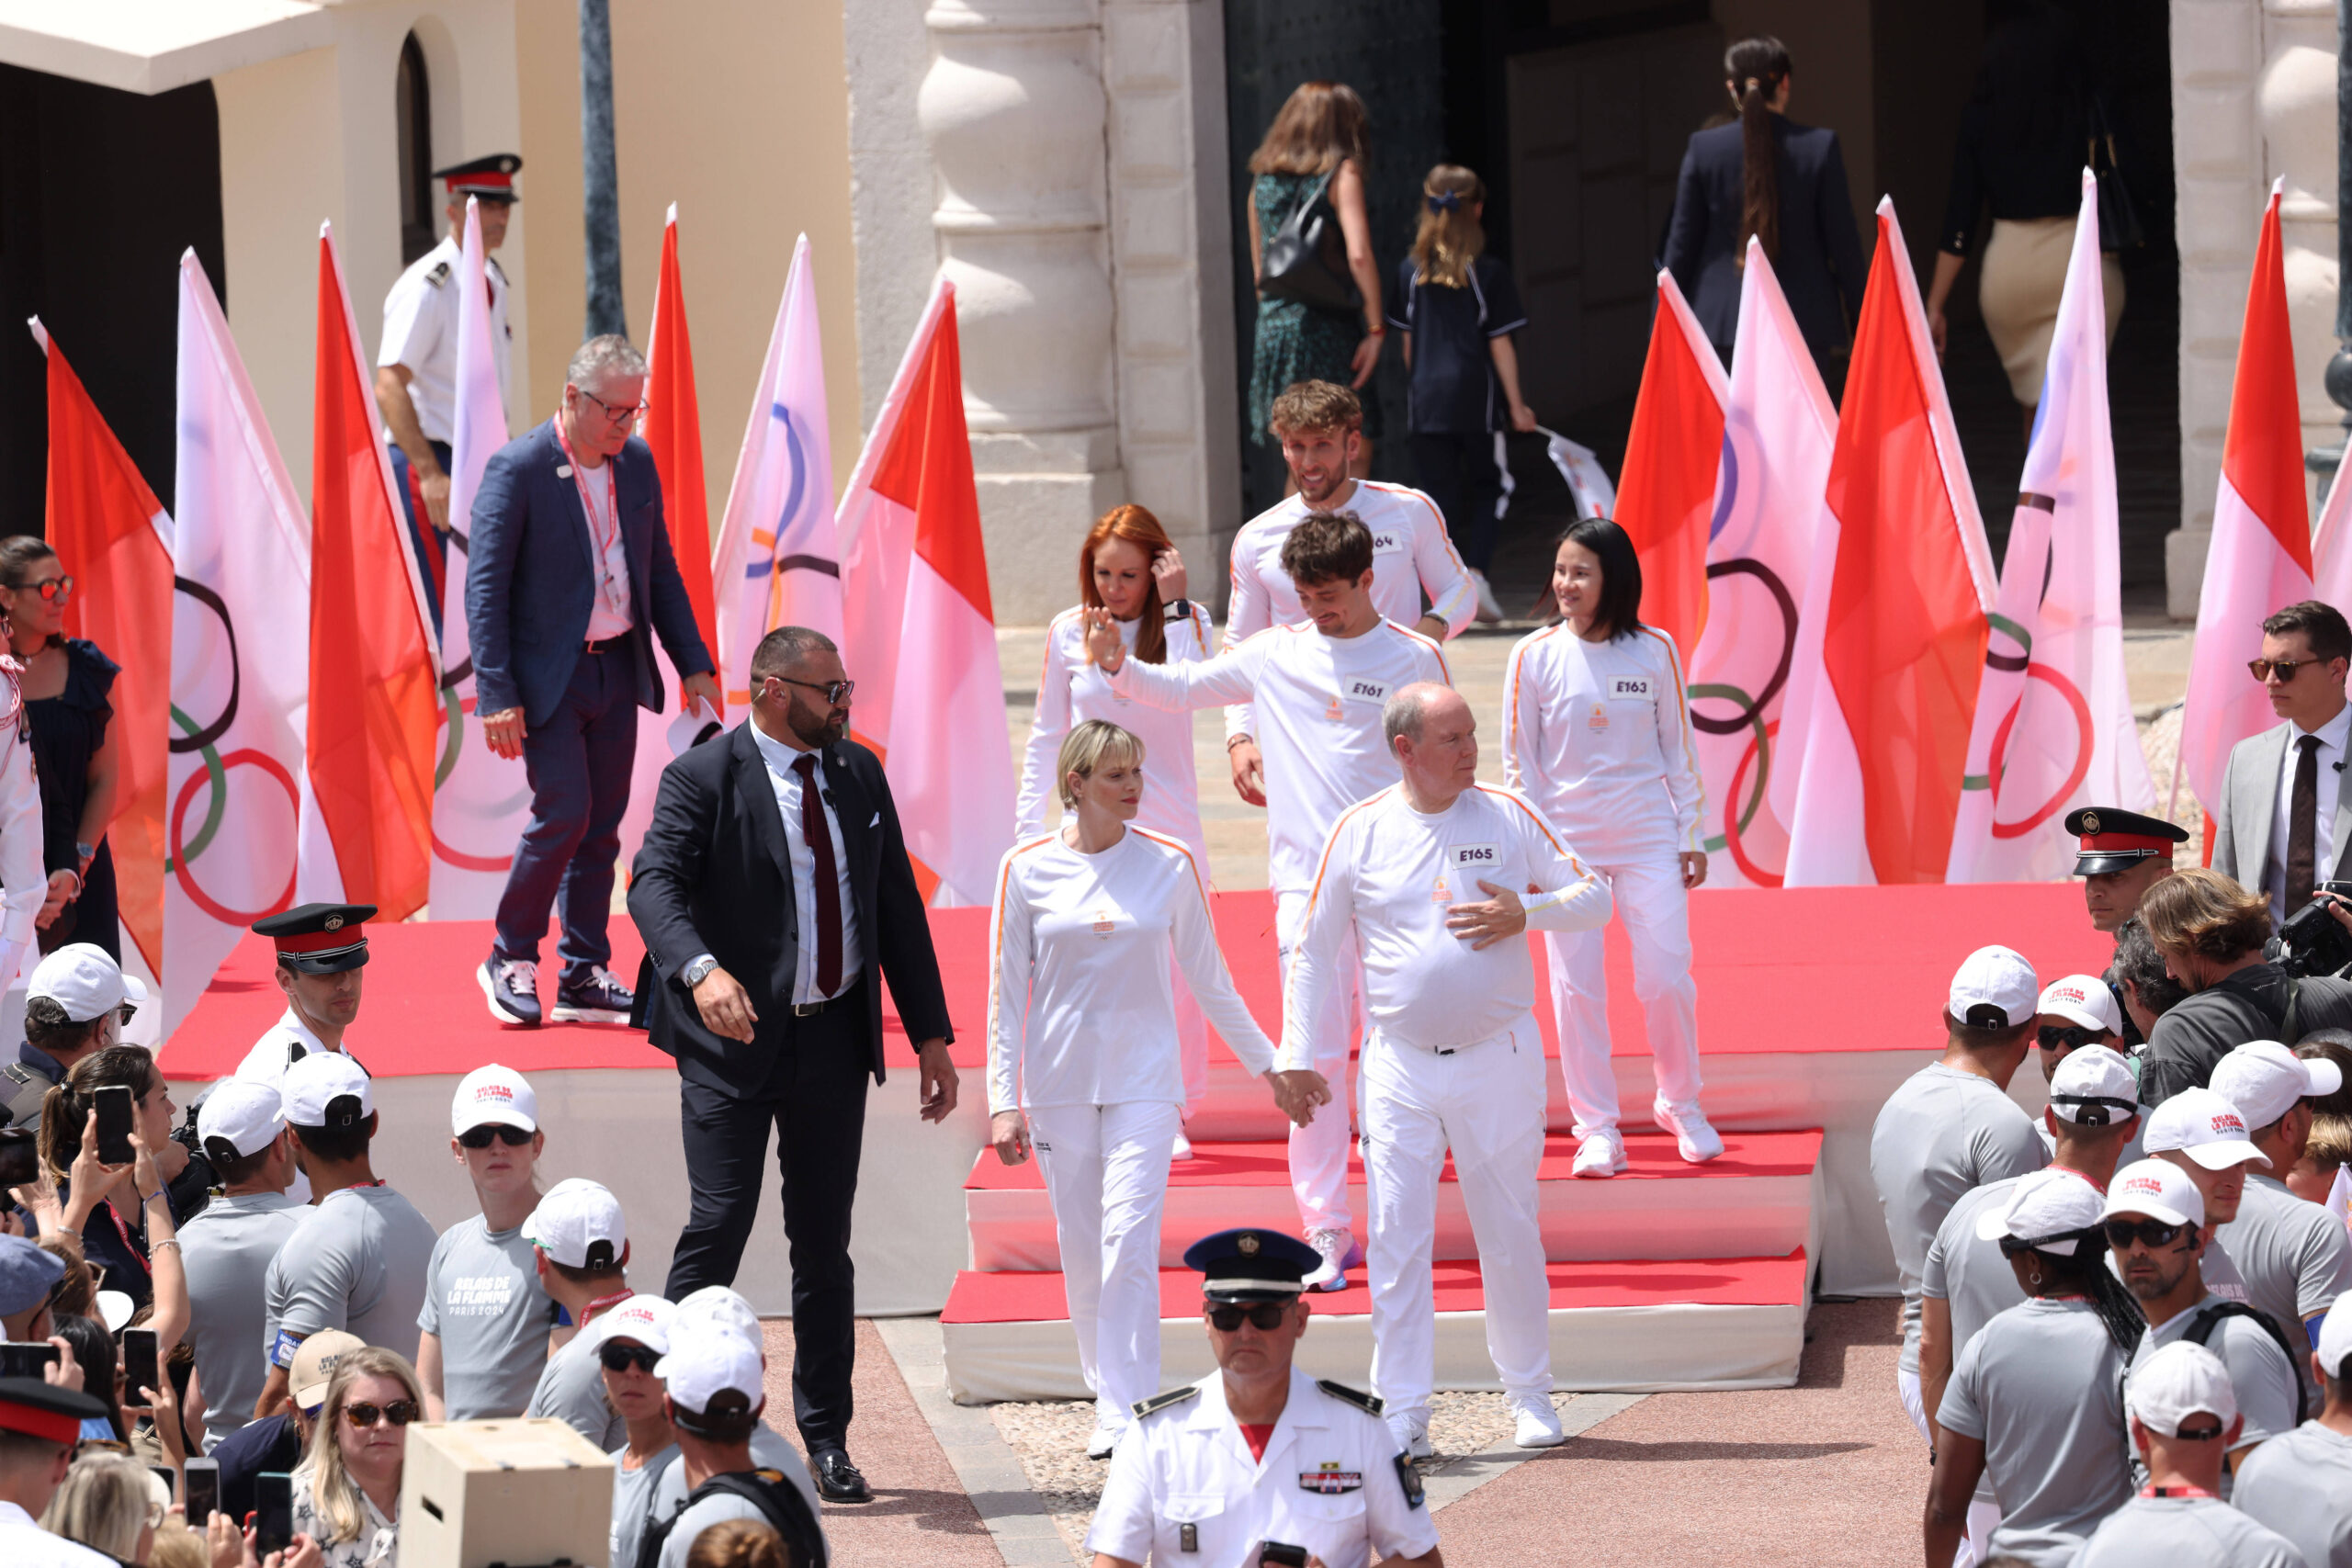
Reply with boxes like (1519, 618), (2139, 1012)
(1087, 1366), (1437, 1568)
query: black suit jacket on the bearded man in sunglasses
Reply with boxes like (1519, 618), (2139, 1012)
(628, 722), (953, 1096)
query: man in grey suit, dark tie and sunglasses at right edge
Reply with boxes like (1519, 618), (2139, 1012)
(2213, 600), (2352, 921)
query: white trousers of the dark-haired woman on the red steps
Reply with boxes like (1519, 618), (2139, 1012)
(1543, 853), (1698, 1138)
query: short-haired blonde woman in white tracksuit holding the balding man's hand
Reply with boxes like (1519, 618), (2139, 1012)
(988, 719), (1329, 1458)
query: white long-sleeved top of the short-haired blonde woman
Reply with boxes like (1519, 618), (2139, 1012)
(988, 828), (1275, 1117)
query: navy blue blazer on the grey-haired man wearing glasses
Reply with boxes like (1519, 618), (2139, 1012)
(466, 421), (715, 728)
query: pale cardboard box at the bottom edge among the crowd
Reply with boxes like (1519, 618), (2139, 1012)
(400, 1417), (628, 1568)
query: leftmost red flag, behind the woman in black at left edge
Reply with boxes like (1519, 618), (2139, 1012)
(40, 332), (172, 976)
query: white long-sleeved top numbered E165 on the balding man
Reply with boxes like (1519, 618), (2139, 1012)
(1277, 783), (1611, 1067)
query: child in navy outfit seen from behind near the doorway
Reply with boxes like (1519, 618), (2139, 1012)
(1387, 163), (1536, 621)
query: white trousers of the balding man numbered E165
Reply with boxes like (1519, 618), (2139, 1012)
(1357, 1018), (1553, 1420)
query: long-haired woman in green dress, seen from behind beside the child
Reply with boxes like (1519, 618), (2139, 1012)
(1249, 83), (1387, 479)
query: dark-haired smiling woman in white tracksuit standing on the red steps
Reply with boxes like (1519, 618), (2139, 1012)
(1503, 517), (1724, 1176)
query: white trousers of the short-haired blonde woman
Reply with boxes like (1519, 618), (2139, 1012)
(1025, 1100), (1179, 1432)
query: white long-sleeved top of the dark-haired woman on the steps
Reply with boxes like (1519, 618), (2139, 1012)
(1503, 621), (1705, 865)
